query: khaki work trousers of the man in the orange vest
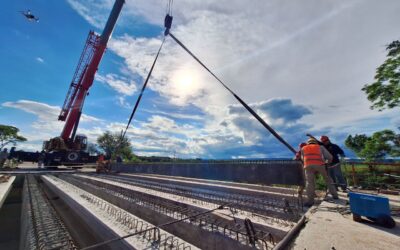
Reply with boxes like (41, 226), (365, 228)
(304, 165), (338, 203)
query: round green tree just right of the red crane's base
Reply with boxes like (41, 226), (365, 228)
(97, 131), (133, 159)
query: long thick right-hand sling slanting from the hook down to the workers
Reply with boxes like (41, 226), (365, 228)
(169, 32), (296, 154)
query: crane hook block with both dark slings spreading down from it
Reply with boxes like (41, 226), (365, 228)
(121, 13), (296, 154)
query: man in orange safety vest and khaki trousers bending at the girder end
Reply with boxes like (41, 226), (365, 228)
(301, 138), (338, 207)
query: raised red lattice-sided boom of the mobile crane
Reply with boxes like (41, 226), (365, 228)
(58, 0), (125, 142)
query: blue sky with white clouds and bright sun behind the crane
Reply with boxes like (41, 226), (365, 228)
(0, 0), (400, 158)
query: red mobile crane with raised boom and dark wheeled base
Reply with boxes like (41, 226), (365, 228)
(43, 0), (125, 166)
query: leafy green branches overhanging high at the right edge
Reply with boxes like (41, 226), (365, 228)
(362, 40), (400, 111)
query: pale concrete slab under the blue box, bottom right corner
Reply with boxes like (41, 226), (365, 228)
(289, 195), (400, 250)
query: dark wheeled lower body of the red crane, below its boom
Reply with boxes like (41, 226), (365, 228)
(43, 134), (89, 167)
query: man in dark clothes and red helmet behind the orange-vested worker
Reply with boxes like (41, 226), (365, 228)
(320, 135), (347, 192)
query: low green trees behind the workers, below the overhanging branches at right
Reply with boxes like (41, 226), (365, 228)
(345, 129), (400, 161)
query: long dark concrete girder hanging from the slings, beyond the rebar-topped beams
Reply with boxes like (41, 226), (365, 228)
(112, 160), (304, 186)
